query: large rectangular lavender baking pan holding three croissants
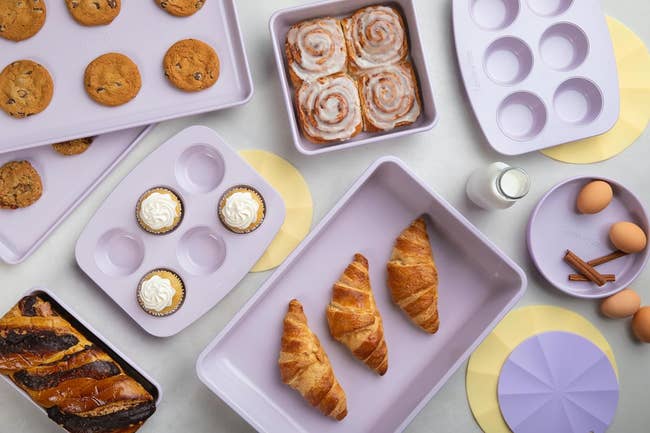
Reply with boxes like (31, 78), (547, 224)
(197, 157), (526, 433)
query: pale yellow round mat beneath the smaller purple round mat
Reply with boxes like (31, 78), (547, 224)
(465, 305), (618, 433)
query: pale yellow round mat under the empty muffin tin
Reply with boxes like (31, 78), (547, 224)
(541, 17), (650, 164)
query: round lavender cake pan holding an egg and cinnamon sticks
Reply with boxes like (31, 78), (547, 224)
(527, 177), (649, 298)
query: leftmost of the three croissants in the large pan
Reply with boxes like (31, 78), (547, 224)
(278, 299), (348, 421)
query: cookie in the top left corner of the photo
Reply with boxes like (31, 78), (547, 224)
(0, 0), (46, 42)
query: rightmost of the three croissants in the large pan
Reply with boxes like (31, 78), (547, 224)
(387, 218), (440, 334)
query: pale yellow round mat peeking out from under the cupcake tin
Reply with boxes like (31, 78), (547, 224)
(239, 150), (314, 272)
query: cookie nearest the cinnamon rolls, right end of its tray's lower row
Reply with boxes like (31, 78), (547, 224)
(163, 39), (220, 92)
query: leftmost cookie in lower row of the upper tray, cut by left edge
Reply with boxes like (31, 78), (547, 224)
(0, 60), (54, 118)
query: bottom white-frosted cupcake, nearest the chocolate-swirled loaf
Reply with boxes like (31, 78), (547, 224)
(137, 269), (185, 317)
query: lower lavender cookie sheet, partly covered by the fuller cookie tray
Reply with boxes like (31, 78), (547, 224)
(0, 127), (151, 265)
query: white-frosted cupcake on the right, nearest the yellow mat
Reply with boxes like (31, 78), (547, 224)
(218, 185), (266, 234)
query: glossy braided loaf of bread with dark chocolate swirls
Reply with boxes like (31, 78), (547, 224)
(0, 295), (156, 433)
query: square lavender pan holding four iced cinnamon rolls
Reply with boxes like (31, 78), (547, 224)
(269, 0), (438, 155)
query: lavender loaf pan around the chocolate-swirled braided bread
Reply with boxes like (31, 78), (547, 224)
(0, 287), (162, 431)
